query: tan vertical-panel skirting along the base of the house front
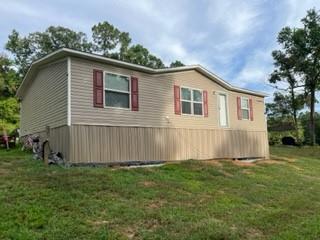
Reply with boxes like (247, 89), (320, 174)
(70, 125), (269, 163)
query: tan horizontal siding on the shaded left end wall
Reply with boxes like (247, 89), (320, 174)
(20, 60), (68, 136)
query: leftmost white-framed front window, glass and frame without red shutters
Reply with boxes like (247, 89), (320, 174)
(104, 73), (130, 108)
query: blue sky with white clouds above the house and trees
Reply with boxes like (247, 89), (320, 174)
(0, 0), (320, 101)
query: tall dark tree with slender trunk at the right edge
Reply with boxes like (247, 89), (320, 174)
(274, 9), (320, 145)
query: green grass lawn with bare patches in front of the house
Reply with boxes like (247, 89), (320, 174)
(0, 147), (320, 240)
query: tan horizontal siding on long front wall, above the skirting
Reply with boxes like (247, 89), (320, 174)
(71, 58), (266, 131)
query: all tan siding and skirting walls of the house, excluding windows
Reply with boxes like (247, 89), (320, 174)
(21, 55), (269, 163)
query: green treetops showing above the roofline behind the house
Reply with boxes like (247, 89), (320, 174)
(6, 21), (183, 75)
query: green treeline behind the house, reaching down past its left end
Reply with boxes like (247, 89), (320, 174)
(0, 21), (184, 135)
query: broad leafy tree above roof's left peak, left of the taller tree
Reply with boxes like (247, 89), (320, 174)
(6, 26), (92, 75)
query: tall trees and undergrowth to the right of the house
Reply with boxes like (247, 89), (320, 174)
(266, 9), (320, 145)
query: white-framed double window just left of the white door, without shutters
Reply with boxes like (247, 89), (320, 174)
(181, 87), (203, 116)
